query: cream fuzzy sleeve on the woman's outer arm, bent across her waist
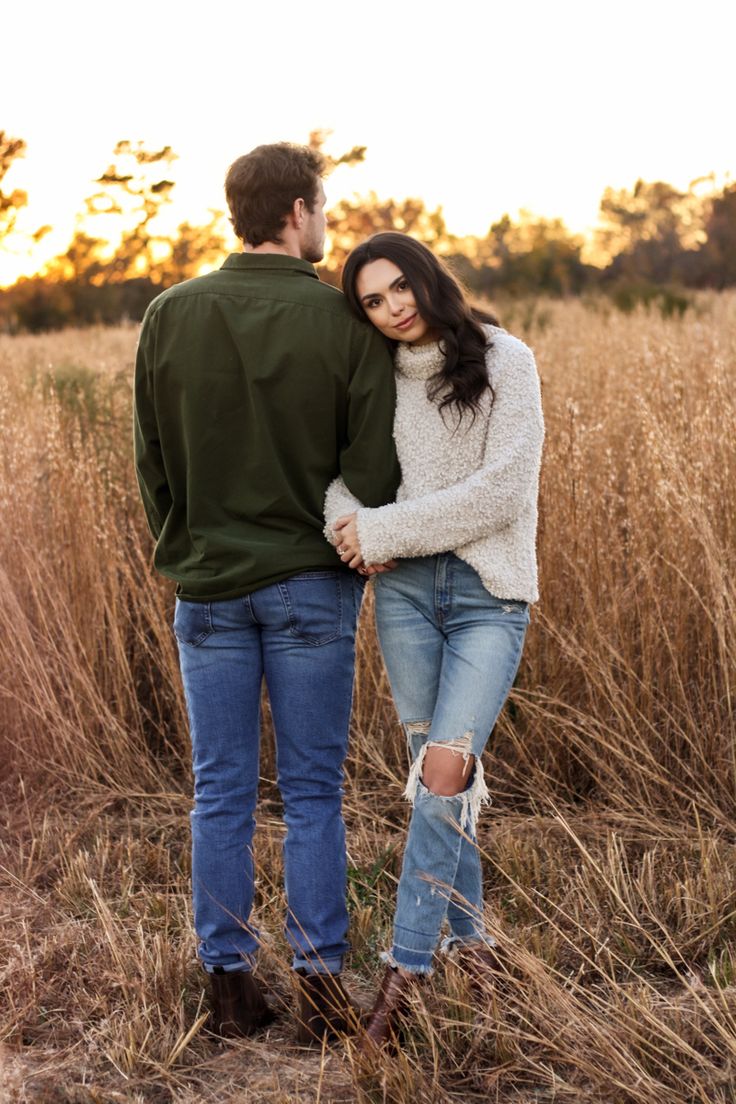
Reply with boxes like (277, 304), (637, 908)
(358, 338), (544, 563)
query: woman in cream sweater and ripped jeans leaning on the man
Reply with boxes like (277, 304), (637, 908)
(326, 233), (544, 1044)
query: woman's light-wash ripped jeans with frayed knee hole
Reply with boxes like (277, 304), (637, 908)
(375, 552), (529, 974)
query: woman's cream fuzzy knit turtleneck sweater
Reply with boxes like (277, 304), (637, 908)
(324, 327), (544, 602)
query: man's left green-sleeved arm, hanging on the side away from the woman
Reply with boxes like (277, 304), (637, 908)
(134, 311), (172, 540)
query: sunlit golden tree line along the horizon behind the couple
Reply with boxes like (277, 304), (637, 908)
(0, 130), (736, 332)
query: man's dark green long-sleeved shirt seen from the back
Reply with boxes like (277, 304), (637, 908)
(135, 253), (399, 601)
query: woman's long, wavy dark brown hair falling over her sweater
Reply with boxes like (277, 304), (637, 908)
(342, 231), (498, 420)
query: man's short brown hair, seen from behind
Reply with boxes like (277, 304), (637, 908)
(225, 141), (326, 246)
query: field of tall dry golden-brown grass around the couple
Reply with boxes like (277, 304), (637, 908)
(0, 295), (736, 1104)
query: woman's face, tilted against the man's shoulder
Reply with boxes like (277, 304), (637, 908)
(355, 257), (435, 344)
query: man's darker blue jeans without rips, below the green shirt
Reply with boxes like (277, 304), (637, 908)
(174, 570), (363, 973)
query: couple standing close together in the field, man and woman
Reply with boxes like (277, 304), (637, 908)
(135, 144), (543, 1048)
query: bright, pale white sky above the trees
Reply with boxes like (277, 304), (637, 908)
(0, 0), (736, 284)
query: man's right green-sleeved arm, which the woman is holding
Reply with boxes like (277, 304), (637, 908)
(340, 322), (401, 507)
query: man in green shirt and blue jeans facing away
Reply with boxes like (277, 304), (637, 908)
(135, 144), (398, 1042)
